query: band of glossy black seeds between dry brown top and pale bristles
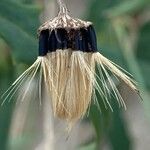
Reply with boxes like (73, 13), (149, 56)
(39, 25), (97, 56)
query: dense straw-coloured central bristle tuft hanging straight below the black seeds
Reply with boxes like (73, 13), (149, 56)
(46, 49), (95, 123)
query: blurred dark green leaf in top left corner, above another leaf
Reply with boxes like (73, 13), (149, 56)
(0, 0), (40, 36)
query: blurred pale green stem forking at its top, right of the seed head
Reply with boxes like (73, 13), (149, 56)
(113, 18), (150, 118)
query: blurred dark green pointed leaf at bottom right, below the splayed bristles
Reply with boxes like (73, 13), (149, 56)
(109, 104), (132, 150)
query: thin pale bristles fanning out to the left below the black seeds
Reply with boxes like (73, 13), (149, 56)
(1, 57), (48, 106)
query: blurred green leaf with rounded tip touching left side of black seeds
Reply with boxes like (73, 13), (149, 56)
(0, 17), (37, 63)
